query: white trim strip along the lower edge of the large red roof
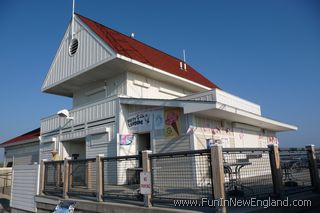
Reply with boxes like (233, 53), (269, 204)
(116, 53), (212, 90)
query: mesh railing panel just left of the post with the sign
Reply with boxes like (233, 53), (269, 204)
(102, 155), (143, 200)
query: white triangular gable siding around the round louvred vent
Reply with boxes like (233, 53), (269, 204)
(42, 15), (115, 91)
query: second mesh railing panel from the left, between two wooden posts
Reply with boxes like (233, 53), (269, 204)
(68, 158), (97, 196)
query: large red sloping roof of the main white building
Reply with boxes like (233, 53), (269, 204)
(76, 14), (218, 89)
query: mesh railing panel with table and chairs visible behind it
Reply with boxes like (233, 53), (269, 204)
(223, 148), (273, 198)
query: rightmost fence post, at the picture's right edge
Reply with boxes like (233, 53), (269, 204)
(306, 144), (320, 192)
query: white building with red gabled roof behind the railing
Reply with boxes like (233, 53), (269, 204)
(3, 14), (297, 211)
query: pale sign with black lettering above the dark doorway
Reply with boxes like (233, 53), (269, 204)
(127, 112), (153, 132)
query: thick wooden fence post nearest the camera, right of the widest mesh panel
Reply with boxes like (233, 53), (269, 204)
(211, 143), (227, 213)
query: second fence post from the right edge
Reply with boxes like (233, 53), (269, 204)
(268, 144), (282, 197)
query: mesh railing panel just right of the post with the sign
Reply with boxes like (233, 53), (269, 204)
(150, 150), (213, 202)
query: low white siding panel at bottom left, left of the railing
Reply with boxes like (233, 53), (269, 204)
(10, 164), (39, 212)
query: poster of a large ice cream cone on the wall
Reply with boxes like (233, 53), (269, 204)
(164, 109), (180, 138)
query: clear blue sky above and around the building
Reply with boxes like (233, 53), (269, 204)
(0, 0), (320, 160)
